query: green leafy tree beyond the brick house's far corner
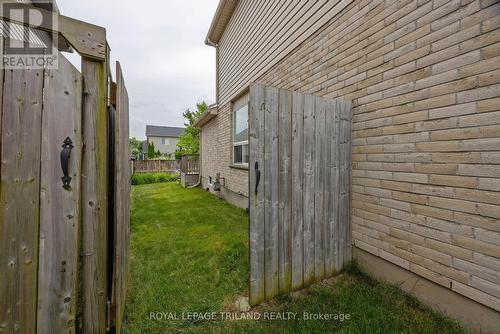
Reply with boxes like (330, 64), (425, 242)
(175, 102), (208, 159)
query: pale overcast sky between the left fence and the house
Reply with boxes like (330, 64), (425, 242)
(57, 0), (219, 138)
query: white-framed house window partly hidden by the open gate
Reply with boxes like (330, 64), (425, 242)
(233, 104), (249, 166)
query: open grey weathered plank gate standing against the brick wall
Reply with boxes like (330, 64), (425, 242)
(249, 85), (352, 305)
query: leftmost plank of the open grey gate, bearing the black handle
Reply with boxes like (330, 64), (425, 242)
(249, 85), (265, 305)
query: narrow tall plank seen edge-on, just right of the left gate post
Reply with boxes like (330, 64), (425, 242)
(111, 62), (131, 333)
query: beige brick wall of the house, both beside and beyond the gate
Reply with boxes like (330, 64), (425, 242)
(202, 0), (500, 311)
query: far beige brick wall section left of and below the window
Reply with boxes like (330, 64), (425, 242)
(201, 103), (248, 197)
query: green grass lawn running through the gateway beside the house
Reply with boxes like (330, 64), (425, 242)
(125, 183), (465, 334)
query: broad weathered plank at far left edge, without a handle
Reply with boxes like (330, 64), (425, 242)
(0, 66), (43, 334)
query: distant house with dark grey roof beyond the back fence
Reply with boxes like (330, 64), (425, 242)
(143, 125), (186, 158)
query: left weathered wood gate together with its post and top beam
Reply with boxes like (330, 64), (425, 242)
(0, 5), (130, 334)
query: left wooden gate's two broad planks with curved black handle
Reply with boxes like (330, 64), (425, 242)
(0, 51), (82, 333)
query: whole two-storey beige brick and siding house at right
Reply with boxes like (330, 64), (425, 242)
(196, 0), (500, 333)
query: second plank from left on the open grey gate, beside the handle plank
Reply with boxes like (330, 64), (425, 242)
(264, 87), (279, 299)
